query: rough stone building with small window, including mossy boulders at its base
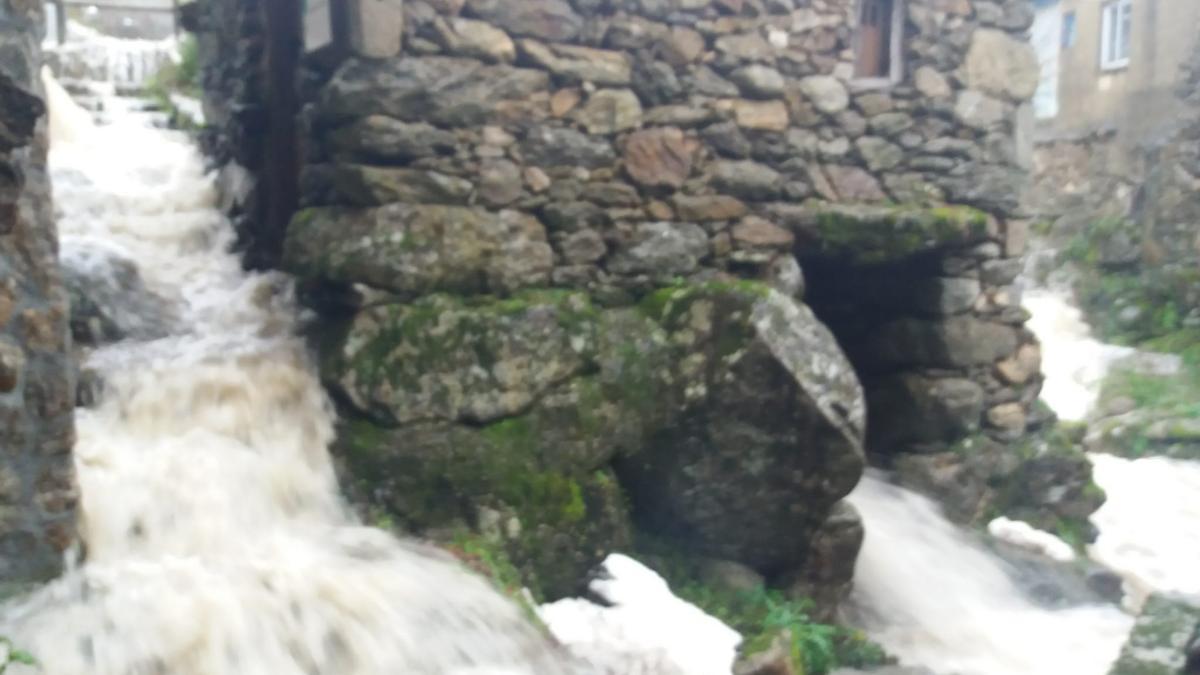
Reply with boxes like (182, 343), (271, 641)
(188, 0), (1086, 605)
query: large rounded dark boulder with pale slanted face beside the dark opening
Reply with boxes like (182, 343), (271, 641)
(618, 285), (865, 572)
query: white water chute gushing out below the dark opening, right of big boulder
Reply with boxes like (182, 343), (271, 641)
(850, 476), (1133, 675)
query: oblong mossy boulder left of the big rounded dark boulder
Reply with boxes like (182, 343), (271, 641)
(323, 292), (599, 424)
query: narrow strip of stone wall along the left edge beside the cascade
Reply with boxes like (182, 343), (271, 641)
(0, 0), (77, 595)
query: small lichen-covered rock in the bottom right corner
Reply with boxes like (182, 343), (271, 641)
(1109, 595), (1200, 675)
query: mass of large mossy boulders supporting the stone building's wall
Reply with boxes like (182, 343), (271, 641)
(322, 282), (864, 597)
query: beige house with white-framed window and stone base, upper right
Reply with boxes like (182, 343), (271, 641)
(1026, 0), (1200, 289)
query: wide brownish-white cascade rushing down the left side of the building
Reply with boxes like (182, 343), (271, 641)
(0, 68), (585, 675)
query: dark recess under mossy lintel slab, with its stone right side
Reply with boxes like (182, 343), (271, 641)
(802, 243), (1039, 465)
